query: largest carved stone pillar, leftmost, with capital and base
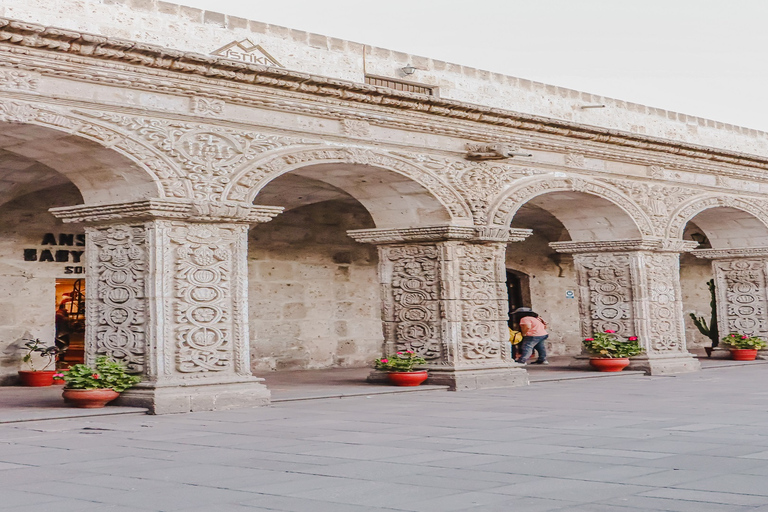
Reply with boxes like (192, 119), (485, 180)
(51, 200), (281, 414)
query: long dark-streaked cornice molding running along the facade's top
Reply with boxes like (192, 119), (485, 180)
(0, 18), (768, 176)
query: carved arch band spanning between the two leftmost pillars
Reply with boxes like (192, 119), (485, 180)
(222, 145), (472, 225)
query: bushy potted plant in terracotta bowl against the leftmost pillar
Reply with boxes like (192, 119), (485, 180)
(56, 356), (141, 409)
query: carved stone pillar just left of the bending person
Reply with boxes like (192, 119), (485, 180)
(348, 226), (530, 390)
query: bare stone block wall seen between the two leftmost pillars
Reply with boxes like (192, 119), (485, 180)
(248, 201), (383, 375)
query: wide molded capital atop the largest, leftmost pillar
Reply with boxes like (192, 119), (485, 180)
(48, 199), (283, 224)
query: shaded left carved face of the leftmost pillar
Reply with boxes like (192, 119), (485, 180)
(86, 225), (148, 373)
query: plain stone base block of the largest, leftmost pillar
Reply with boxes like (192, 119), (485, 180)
(113, 378), (270, 414)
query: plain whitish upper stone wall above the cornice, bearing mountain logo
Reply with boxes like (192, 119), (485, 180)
(0, 0), (768, 156)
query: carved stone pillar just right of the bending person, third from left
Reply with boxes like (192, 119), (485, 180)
(550, 240), (701, 375)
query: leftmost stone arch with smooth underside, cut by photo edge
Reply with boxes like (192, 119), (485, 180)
(0, 99), (177, 203)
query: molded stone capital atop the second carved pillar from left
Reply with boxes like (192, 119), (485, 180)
(347, 226), (533, 245)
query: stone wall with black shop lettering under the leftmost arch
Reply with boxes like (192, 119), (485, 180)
(0, 185), (85, 384)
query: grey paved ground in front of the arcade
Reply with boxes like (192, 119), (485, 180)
(0, 365), (768, 512)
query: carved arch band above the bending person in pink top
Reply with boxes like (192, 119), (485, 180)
(488, 176), (658, 236)
